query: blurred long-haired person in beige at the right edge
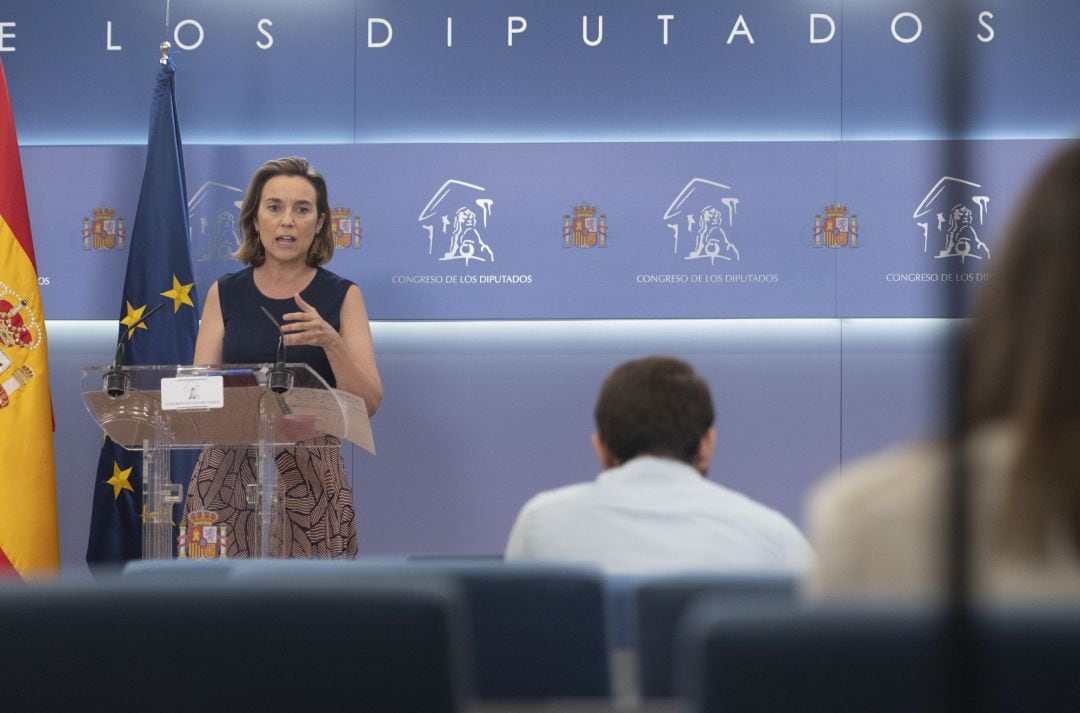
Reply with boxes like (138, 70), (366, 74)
(807, 143), (1080, 600)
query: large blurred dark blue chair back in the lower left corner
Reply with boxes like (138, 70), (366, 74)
(0, 583), (465, 713)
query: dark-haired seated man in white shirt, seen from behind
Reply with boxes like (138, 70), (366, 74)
(507, 357), (811, 574)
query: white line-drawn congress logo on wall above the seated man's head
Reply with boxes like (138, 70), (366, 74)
(663, 178), (742, 265)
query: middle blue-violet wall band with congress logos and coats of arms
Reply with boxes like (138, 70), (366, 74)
(25, 139), (1057, 320)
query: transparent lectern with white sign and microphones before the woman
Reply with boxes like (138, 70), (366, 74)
(82, 364), (375, 560)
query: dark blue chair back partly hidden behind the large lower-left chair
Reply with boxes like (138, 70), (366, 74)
(231, 559), (611, 700)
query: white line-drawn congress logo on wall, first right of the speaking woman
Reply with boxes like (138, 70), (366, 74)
(417, 178), (495, 267)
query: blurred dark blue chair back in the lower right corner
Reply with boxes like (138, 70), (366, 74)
(678, 601), (1080, 713)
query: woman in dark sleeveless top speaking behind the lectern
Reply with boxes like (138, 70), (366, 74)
(184, 157), (382, 559)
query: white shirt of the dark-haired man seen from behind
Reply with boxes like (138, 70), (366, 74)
(507, 456), (811, 574)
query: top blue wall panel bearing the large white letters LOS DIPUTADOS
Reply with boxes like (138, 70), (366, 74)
(6, 0), (1080, 145)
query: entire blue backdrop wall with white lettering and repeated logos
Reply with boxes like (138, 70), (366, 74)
(0, 0), (1080, 570)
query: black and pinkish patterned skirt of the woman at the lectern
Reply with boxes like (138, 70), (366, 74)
(184, 435), (356, 560)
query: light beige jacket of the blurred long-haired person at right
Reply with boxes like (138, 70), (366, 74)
(806, 426), (1080, 601)
